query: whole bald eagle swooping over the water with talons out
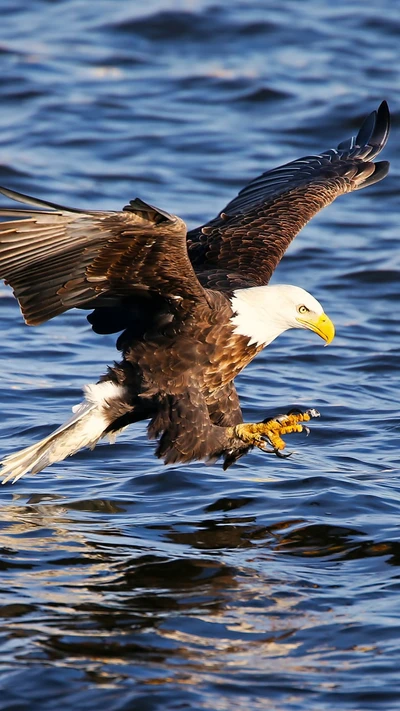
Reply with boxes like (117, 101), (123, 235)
(0, 102), (389, 482)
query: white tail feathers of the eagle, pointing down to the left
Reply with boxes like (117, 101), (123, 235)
(0, 381), (123, 484)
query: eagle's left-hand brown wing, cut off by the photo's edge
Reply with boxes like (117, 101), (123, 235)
(0, 188), (205, 325)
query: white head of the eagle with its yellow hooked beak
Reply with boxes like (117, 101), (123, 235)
(231, 284), (335, 346)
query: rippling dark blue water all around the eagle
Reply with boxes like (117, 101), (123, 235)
(0, 0), (400, 711)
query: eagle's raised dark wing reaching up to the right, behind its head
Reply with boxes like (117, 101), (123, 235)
(188, 101), (390, 291)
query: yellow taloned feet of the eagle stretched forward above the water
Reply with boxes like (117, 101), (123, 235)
(231, 409), (319, 456)
